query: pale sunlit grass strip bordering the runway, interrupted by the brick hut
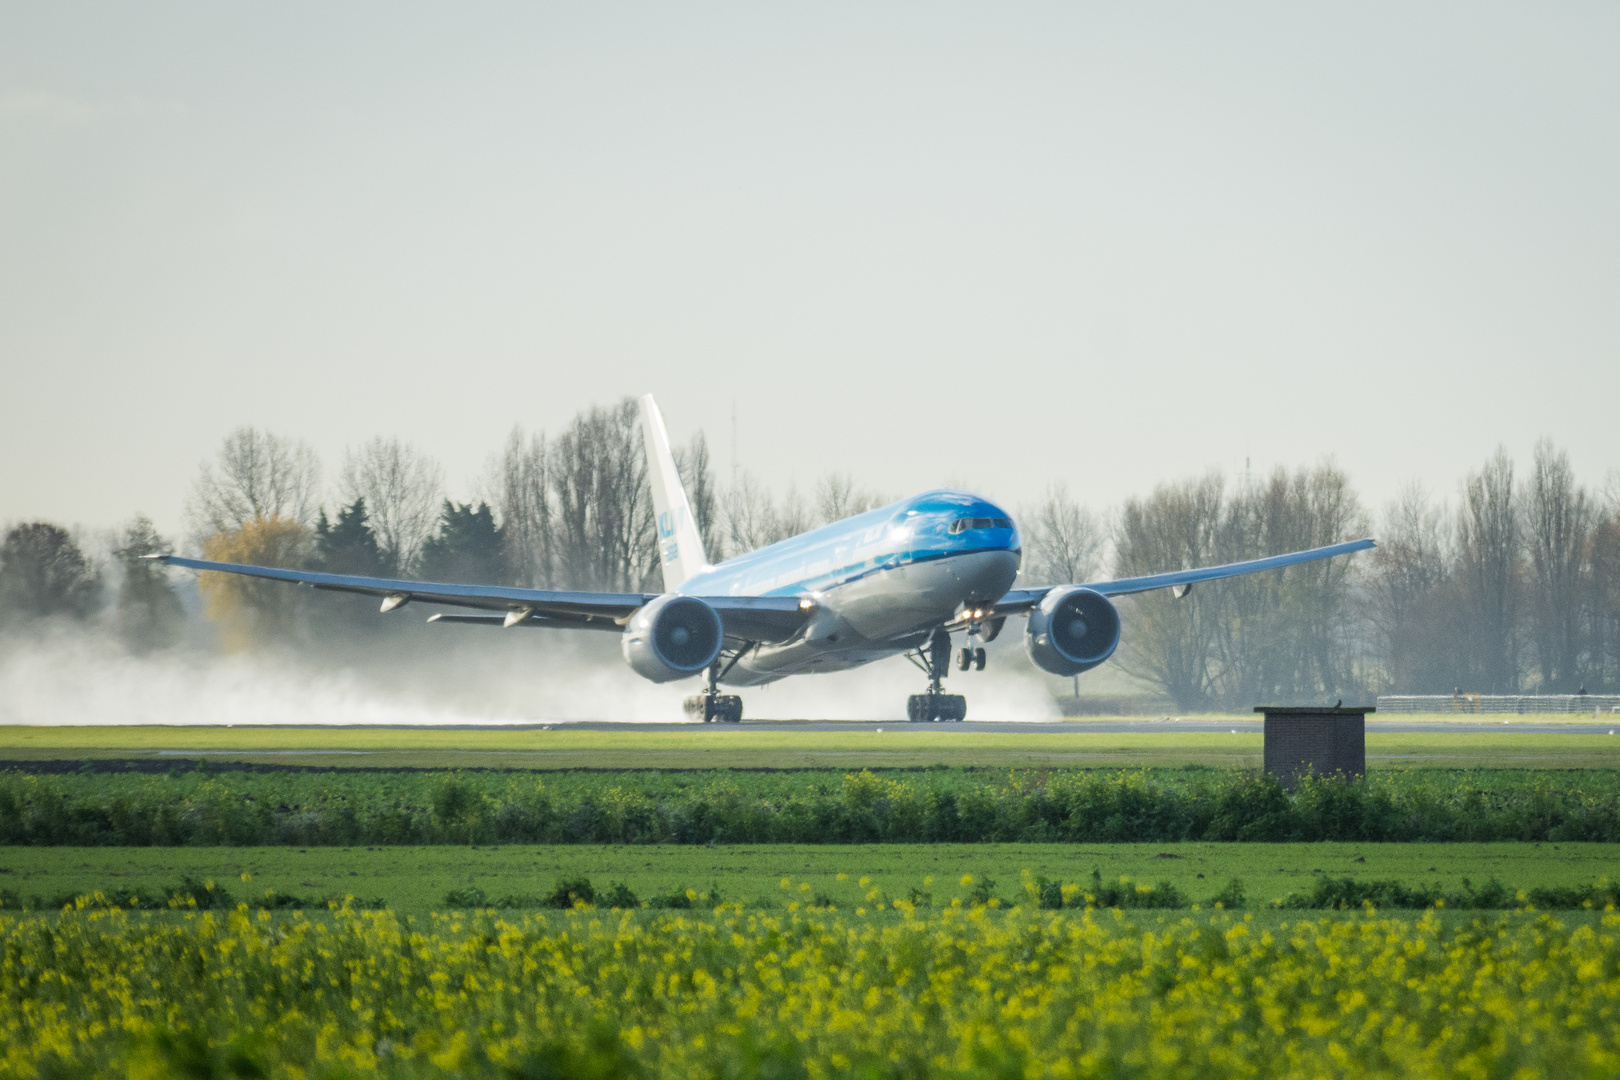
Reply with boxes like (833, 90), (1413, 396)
(0, 717), (1620, 769)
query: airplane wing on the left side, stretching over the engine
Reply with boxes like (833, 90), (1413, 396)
(146, 555), (815, 641)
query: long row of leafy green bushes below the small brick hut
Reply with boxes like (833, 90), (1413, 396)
(0, 769), (1620, 847)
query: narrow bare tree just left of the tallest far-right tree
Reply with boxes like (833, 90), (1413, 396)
(1456, 447), (1523, 693)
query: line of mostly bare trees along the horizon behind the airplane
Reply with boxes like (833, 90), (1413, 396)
(0, 398), (1620, 711)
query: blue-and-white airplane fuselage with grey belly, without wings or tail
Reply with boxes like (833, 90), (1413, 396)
(679, 491), (1021, 687)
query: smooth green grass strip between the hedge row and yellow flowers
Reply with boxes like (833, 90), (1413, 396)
(0, 844), (1620, 915)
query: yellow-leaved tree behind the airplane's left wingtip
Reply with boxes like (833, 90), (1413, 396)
(198, 517), (311, 653)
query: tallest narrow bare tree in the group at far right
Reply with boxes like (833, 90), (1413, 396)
(1521, 439), (1592, 693)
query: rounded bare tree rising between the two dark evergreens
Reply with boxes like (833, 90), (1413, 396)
(339, 436), (444, 575)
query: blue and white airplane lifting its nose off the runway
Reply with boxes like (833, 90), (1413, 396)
(147, 395), (1375, 724)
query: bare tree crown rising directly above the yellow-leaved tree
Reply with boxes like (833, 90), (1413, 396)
(186, 427), (321, 539)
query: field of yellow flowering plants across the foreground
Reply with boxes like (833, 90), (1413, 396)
(0, 892), (1620, 1080)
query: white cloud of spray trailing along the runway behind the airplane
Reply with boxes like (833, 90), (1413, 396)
(0, 628), (1056, 725)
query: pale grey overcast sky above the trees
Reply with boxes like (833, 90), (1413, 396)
(0, 3), (1620, 531)
